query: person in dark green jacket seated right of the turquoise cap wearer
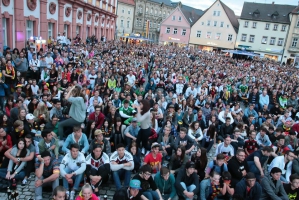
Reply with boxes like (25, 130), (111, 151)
(154, 167), (178, 200)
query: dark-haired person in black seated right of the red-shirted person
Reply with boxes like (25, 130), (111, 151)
(169, 146), (189, 175)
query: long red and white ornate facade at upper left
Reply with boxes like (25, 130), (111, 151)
(0, 0), (117, 49)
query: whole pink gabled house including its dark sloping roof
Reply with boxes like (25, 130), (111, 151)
(159, 2), (203, 45)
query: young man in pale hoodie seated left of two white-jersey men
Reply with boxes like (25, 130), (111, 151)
(59, 143), (86, 199)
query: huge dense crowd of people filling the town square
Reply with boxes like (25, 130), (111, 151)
(0, 36), (299, 200)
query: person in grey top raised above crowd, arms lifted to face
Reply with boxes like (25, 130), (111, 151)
(58, 86), (86, 140)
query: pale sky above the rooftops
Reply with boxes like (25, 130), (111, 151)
(179, 0), (298, 16)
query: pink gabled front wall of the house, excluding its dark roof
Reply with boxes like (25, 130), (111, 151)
(159, 8), (191, 44)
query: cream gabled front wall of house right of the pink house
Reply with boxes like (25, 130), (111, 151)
(189, 2), (237, 49)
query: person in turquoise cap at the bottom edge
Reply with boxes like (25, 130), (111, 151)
(113, 179), (147, 200)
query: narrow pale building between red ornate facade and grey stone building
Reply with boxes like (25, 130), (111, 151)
(116, 0), (135, 38)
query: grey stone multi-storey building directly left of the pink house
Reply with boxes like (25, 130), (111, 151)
(133, 0), (175, 42)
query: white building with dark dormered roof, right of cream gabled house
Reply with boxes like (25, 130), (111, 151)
(235, 2), (295, 61)
